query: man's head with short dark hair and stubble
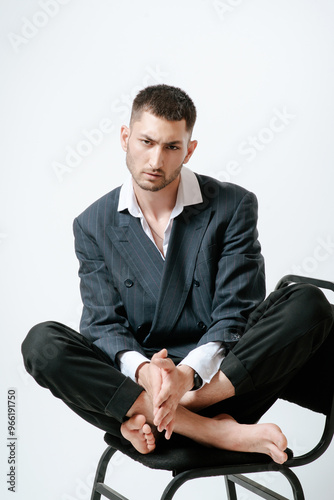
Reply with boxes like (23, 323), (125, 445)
(121, 85), (197, 191)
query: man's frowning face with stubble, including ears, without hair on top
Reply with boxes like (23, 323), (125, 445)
(121, 111), (197, 191)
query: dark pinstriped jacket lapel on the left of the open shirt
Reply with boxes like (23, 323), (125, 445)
(106, 212), (164, 301)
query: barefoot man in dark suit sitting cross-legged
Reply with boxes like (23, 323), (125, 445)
(23, 85), (333, 463)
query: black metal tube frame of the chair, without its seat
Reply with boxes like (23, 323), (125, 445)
(91, 275), (334, 500)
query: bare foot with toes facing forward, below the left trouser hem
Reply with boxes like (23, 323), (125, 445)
(121, 415), (155, 455)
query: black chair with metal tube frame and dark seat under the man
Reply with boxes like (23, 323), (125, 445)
(91, 275), (334, 500)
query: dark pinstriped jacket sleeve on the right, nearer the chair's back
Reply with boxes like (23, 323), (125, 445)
(199, 192), (265, 350)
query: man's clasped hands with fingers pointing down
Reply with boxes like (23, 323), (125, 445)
(137, 349), (194, 439)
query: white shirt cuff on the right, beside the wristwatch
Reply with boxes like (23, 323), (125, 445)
(179, 341), (225, 389)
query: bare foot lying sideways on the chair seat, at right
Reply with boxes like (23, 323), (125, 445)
(197, 415), (288, 464)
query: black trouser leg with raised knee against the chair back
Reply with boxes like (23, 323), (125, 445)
(205, 285), (333, 422)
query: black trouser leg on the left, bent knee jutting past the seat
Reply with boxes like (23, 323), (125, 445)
(22, 322), (143, 436)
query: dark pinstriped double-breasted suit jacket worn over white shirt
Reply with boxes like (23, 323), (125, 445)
(74, 175), (265, 364)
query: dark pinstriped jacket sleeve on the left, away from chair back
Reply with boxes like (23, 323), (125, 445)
(73, 219), (145, 364)
